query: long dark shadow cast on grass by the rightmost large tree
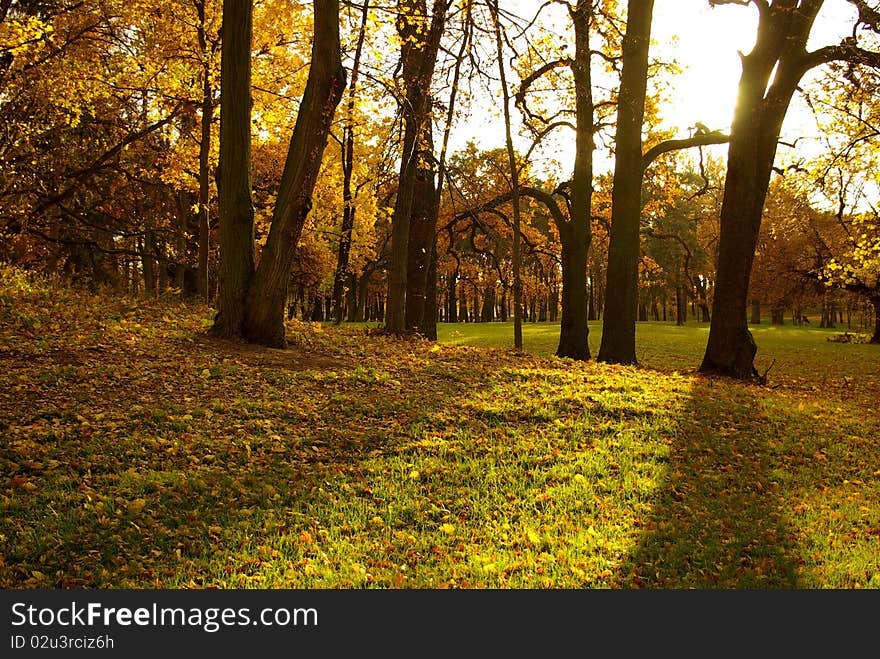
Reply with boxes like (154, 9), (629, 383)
(619, 382), (800, 589)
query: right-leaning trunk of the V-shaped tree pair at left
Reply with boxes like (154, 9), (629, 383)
(242, 0), (345, 347)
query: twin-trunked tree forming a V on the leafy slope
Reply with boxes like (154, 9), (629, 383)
(213, 0), (345, 347)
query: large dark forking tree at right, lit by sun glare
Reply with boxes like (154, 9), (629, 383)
(700, 0), (880, 380)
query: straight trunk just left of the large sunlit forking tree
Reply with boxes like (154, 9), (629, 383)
(598, 0), (654, 364)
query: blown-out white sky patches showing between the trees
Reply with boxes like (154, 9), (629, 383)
(466, 0), (855, 175)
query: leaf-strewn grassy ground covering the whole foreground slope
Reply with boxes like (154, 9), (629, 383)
(0, 268), (880, 588)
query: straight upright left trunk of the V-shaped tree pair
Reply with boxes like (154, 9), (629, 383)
(211, 0), (254, 338)
